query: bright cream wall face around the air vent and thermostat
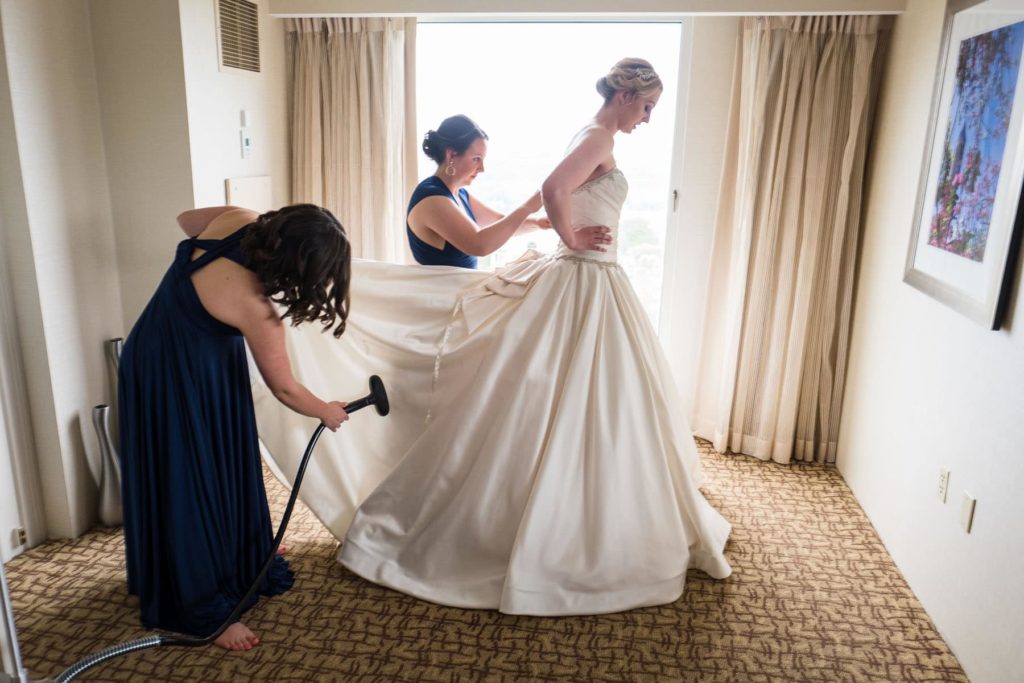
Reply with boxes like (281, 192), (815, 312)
(180, 0), (290, 210)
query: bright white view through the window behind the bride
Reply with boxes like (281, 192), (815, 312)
(416, 23), (680, 326)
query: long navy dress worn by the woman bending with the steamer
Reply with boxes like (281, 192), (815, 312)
(118, 227), (293, 636)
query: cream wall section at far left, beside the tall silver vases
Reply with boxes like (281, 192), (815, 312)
(0, 0), (122, 536)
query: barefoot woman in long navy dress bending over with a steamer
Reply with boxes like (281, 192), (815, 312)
(119, 204), (351, 650)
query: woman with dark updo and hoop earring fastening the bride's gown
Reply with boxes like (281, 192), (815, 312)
(406, 115), (610, 268)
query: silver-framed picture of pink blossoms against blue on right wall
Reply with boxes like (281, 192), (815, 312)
(903, 0), (1024, 330)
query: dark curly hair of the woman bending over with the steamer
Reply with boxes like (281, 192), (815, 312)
(240, 204), (352, 337)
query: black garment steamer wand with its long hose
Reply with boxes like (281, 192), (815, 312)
(45, 375), (391, 683)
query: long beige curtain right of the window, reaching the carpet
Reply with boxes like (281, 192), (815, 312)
(693, 16), (891, 463)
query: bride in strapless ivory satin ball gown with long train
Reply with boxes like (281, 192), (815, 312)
(251, 59), (731, 615)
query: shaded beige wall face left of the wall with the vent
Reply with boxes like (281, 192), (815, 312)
(90, 0), (197, 336)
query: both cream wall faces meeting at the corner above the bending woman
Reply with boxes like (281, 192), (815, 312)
(90, 0), (290, 334)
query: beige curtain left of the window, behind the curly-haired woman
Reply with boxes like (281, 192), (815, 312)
(288, 18), (417, 262)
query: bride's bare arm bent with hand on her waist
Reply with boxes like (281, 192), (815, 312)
(541, 128), (612, 251)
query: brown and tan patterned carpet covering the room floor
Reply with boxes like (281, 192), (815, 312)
(7, 444), (967, 683)
